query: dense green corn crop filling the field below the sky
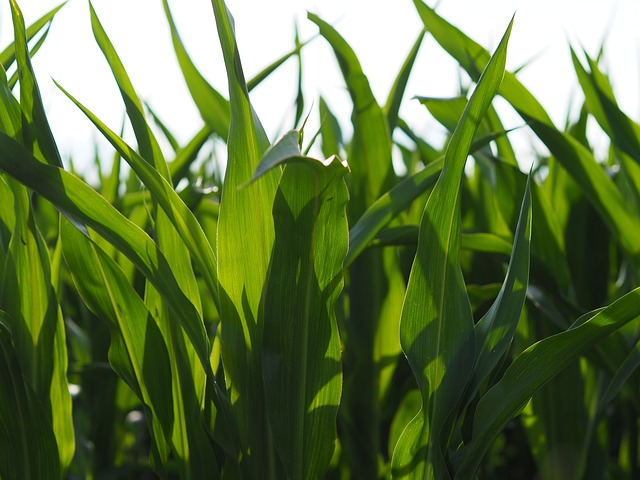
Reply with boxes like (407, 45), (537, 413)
(0, 0), (640, 479)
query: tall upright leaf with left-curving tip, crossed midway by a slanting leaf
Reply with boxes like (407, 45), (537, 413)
(308, 13), (405, 478)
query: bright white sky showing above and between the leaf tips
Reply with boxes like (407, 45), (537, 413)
(0, 0), (640, 172)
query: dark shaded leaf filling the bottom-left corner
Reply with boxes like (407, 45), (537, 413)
(0, 316), (62, 480)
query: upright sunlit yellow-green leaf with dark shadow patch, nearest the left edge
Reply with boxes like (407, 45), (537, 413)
(0, 178), (75, 471)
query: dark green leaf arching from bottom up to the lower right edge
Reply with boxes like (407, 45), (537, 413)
(456, 288), (640, 479)
